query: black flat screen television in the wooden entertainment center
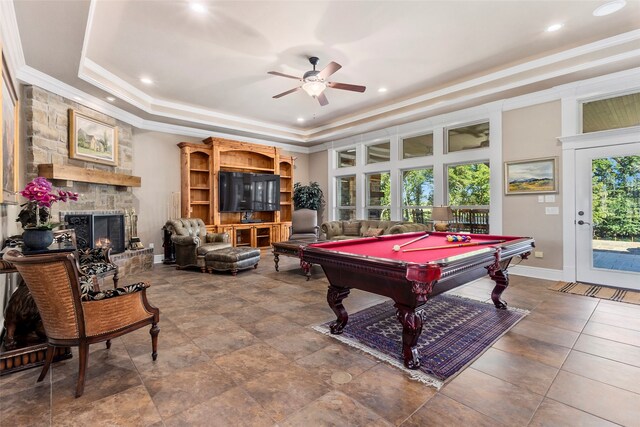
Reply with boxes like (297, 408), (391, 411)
(218, 171), (280, 212)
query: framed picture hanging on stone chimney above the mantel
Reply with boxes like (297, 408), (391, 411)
(69, 109), (118, 166)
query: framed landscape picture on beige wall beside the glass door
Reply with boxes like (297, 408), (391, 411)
(504, 157), (558, 195)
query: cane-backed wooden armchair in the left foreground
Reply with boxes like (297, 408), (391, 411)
(4, 250), (160, 397)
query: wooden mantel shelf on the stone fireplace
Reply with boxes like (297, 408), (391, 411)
(38, 163), (142, 187)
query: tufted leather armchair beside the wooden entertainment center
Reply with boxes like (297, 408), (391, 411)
(165, 218), (232, 273)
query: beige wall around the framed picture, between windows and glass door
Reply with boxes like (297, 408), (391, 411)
(502, 101), (564, 270)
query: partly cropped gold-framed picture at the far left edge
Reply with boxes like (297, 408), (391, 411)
(0, 50), (20, 203)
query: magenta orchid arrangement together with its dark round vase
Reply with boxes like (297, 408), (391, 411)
(16, 177), (78, 250)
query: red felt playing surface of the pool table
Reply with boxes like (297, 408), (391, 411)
(309, 232), (522, 264)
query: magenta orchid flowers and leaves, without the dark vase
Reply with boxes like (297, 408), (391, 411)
(16, 177), (78, 230)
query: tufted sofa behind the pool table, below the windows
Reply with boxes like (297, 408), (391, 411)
(320, 220), (431, 240)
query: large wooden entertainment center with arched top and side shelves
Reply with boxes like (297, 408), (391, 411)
(178, 138), (294, 248)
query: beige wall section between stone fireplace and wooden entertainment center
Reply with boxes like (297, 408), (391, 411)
(133, 128), (202, 255)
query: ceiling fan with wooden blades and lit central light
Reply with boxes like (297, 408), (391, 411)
(268, 56), (367, 106)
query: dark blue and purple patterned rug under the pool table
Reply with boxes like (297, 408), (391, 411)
(314, 295), (528, 389)
